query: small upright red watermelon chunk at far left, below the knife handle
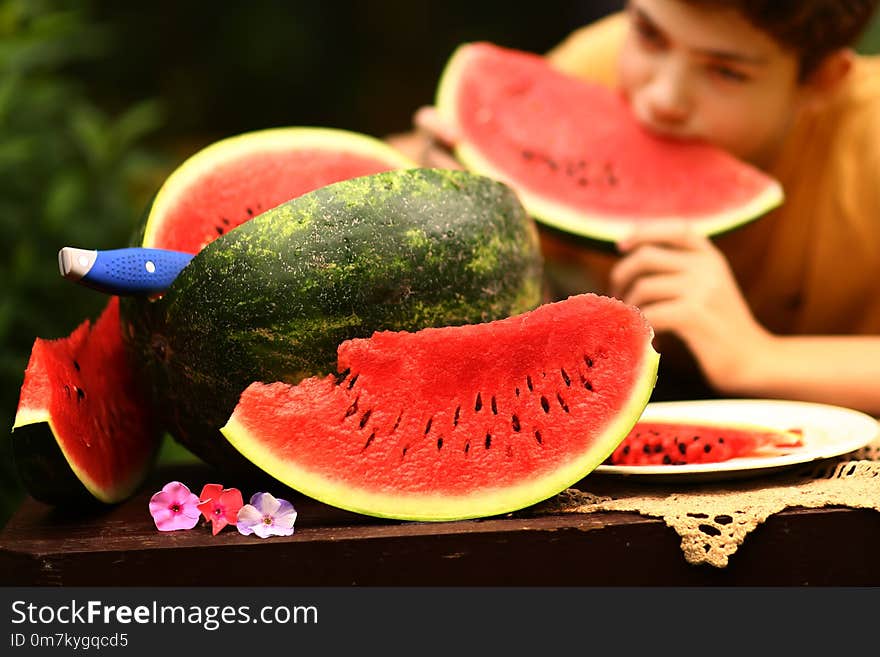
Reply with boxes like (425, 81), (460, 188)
(13, 297), (160, 503)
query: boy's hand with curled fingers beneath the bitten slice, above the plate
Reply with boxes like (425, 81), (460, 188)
(610, 222), (769, 392)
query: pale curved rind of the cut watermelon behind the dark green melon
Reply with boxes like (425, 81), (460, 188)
(140, 127), (416, 247)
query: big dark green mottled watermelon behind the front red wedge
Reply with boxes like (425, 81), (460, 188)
(124, 169), (542, 470)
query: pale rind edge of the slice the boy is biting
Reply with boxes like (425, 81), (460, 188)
(435, 43), (785, 242)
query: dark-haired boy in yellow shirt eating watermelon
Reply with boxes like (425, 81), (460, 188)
(392, 0), (880, 415)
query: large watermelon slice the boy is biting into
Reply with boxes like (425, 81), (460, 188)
(436, 43), (782, 241)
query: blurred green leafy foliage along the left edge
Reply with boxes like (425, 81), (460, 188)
(0, 0), (170, 524)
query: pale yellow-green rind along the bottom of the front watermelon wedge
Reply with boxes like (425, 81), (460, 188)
(220, 341), (660, 522)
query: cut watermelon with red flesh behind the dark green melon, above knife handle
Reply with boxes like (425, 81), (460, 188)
(141, 127), (415, 253)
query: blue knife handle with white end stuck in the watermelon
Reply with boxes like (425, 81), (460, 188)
(58, 246), (193, 295)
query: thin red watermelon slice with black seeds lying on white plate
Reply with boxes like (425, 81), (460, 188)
(608, 421), (803, 465)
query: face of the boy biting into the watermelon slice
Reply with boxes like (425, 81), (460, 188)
(619, 0), (804, 167)
